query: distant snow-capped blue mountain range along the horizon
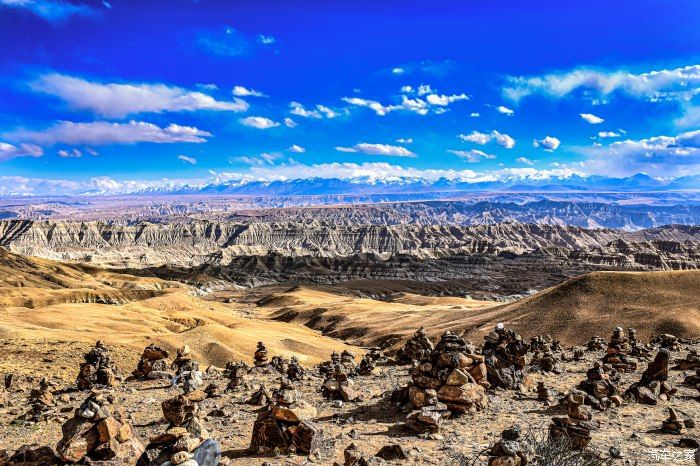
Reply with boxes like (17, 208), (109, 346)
(130, 173), (700, 198)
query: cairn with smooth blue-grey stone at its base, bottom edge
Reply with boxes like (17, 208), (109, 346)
(137, 390), (221, 466)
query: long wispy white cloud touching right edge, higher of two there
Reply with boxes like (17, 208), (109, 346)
(503, 65), (700, 101)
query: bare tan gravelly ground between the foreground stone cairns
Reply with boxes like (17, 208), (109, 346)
(0, 334), (700, 465)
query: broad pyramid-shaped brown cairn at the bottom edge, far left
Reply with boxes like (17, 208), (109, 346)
(56, 391), (144, 464)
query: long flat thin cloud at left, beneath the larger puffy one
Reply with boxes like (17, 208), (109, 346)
(6, 121), (211, 146)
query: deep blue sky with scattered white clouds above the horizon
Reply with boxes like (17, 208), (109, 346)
(0, 0), (700, 194)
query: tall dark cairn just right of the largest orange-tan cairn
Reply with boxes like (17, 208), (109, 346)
(482, 324), (529, 390)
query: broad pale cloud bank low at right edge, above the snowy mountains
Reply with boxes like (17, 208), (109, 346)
(575, 130), (700, 177)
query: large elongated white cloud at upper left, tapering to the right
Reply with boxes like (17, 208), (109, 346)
(30, 73), (248, 118)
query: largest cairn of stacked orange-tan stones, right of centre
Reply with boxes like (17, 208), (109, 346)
(406, 331), (488, 432)
